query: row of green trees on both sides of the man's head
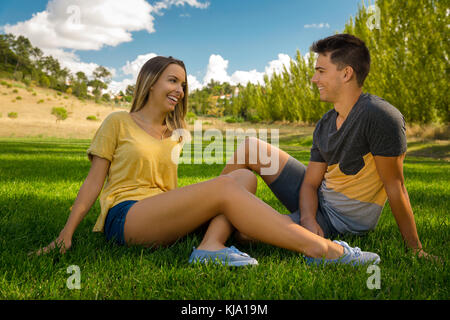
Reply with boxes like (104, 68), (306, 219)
(191, 0), (450, 123)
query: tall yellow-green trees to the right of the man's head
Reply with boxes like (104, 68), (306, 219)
(344, 0), (450, 123)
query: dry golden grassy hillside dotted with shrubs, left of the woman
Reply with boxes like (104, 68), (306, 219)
(0, 80), (126, 139)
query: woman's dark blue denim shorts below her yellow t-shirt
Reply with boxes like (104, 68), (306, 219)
(104, 200), (137, 246)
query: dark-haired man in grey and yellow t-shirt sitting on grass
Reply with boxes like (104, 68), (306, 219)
(220, 34), (434, 256)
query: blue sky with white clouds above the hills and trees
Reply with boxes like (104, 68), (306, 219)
(0, 0), (367, 92)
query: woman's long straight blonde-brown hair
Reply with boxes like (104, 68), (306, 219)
(130, 56), (188, 131)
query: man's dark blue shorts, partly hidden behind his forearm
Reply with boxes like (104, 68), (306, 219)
(269, 157), (338, 238)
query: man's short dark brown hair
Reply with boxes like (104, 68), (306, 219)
(311, 33), (370, 87)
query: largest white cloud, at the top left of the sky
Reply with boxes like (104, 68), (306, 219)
(4, 0), (155, 50)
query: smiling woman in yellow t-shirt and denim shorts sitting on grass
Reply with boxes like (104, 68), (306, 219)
(38, 56), (379, 266)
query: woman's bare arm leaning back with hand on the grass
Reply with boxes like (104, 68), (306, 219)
(36, 156), (110, 255)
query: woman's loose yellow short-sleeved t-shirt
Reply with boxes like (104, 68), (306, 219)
(87, 111), (182, 232)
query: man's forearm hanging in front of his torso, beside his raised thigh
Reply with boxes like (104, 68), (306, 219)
(299, 161), (327, 237)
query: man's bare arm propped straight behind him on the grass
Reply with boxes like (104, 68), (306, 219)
(374, 154), (428, 252)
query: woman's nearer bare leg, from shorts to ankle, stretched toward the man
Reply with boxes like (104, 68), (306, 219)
(124, 175), (344, 259)
